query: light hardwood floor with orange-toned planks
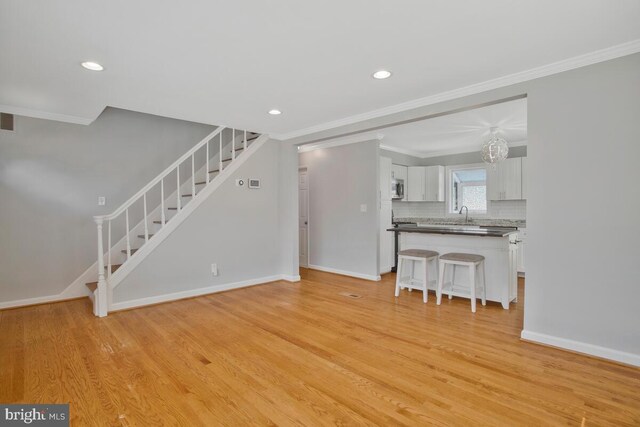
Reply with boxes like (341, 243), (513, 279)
(0, 271), (640, 426)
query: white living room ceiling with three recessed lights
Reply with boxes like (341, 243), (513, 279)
(0, 0), (640, 135)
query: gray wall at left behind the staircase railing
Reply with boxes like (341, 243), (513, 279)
(0, 108), (214, 302)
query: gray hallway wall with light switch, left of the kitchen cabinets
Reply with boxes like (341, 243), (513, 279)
(300, 140), (379, 277)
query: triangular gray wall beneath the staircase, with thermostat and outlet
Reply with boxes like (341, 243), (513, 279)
(113, 141), (297, 303)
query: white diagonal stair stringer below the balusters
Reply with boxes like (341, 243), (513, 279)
(107, 135), (270, 308)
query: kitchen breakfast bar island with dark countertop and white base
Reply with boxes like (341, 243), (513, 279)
(388, 224), (518, 310)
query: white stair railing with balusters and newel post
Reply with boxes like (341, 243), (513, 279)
(93, 126), (257, 317)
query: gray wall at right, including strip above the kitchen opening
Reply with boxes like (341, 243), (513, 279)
(293, 54), (640, 365)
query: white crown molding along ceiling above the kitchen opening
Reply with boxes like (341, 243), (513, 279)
(272, 39), (640, 140)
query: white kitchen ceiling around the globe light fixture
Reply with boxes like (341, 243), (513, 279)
(378, 99), (527, 157)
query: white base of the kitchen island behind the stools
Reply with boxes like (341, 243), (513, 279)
(398, 232), (518, 310)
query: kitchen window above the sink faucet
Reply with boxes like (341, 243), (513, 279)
(447, 166), (487, 215)
